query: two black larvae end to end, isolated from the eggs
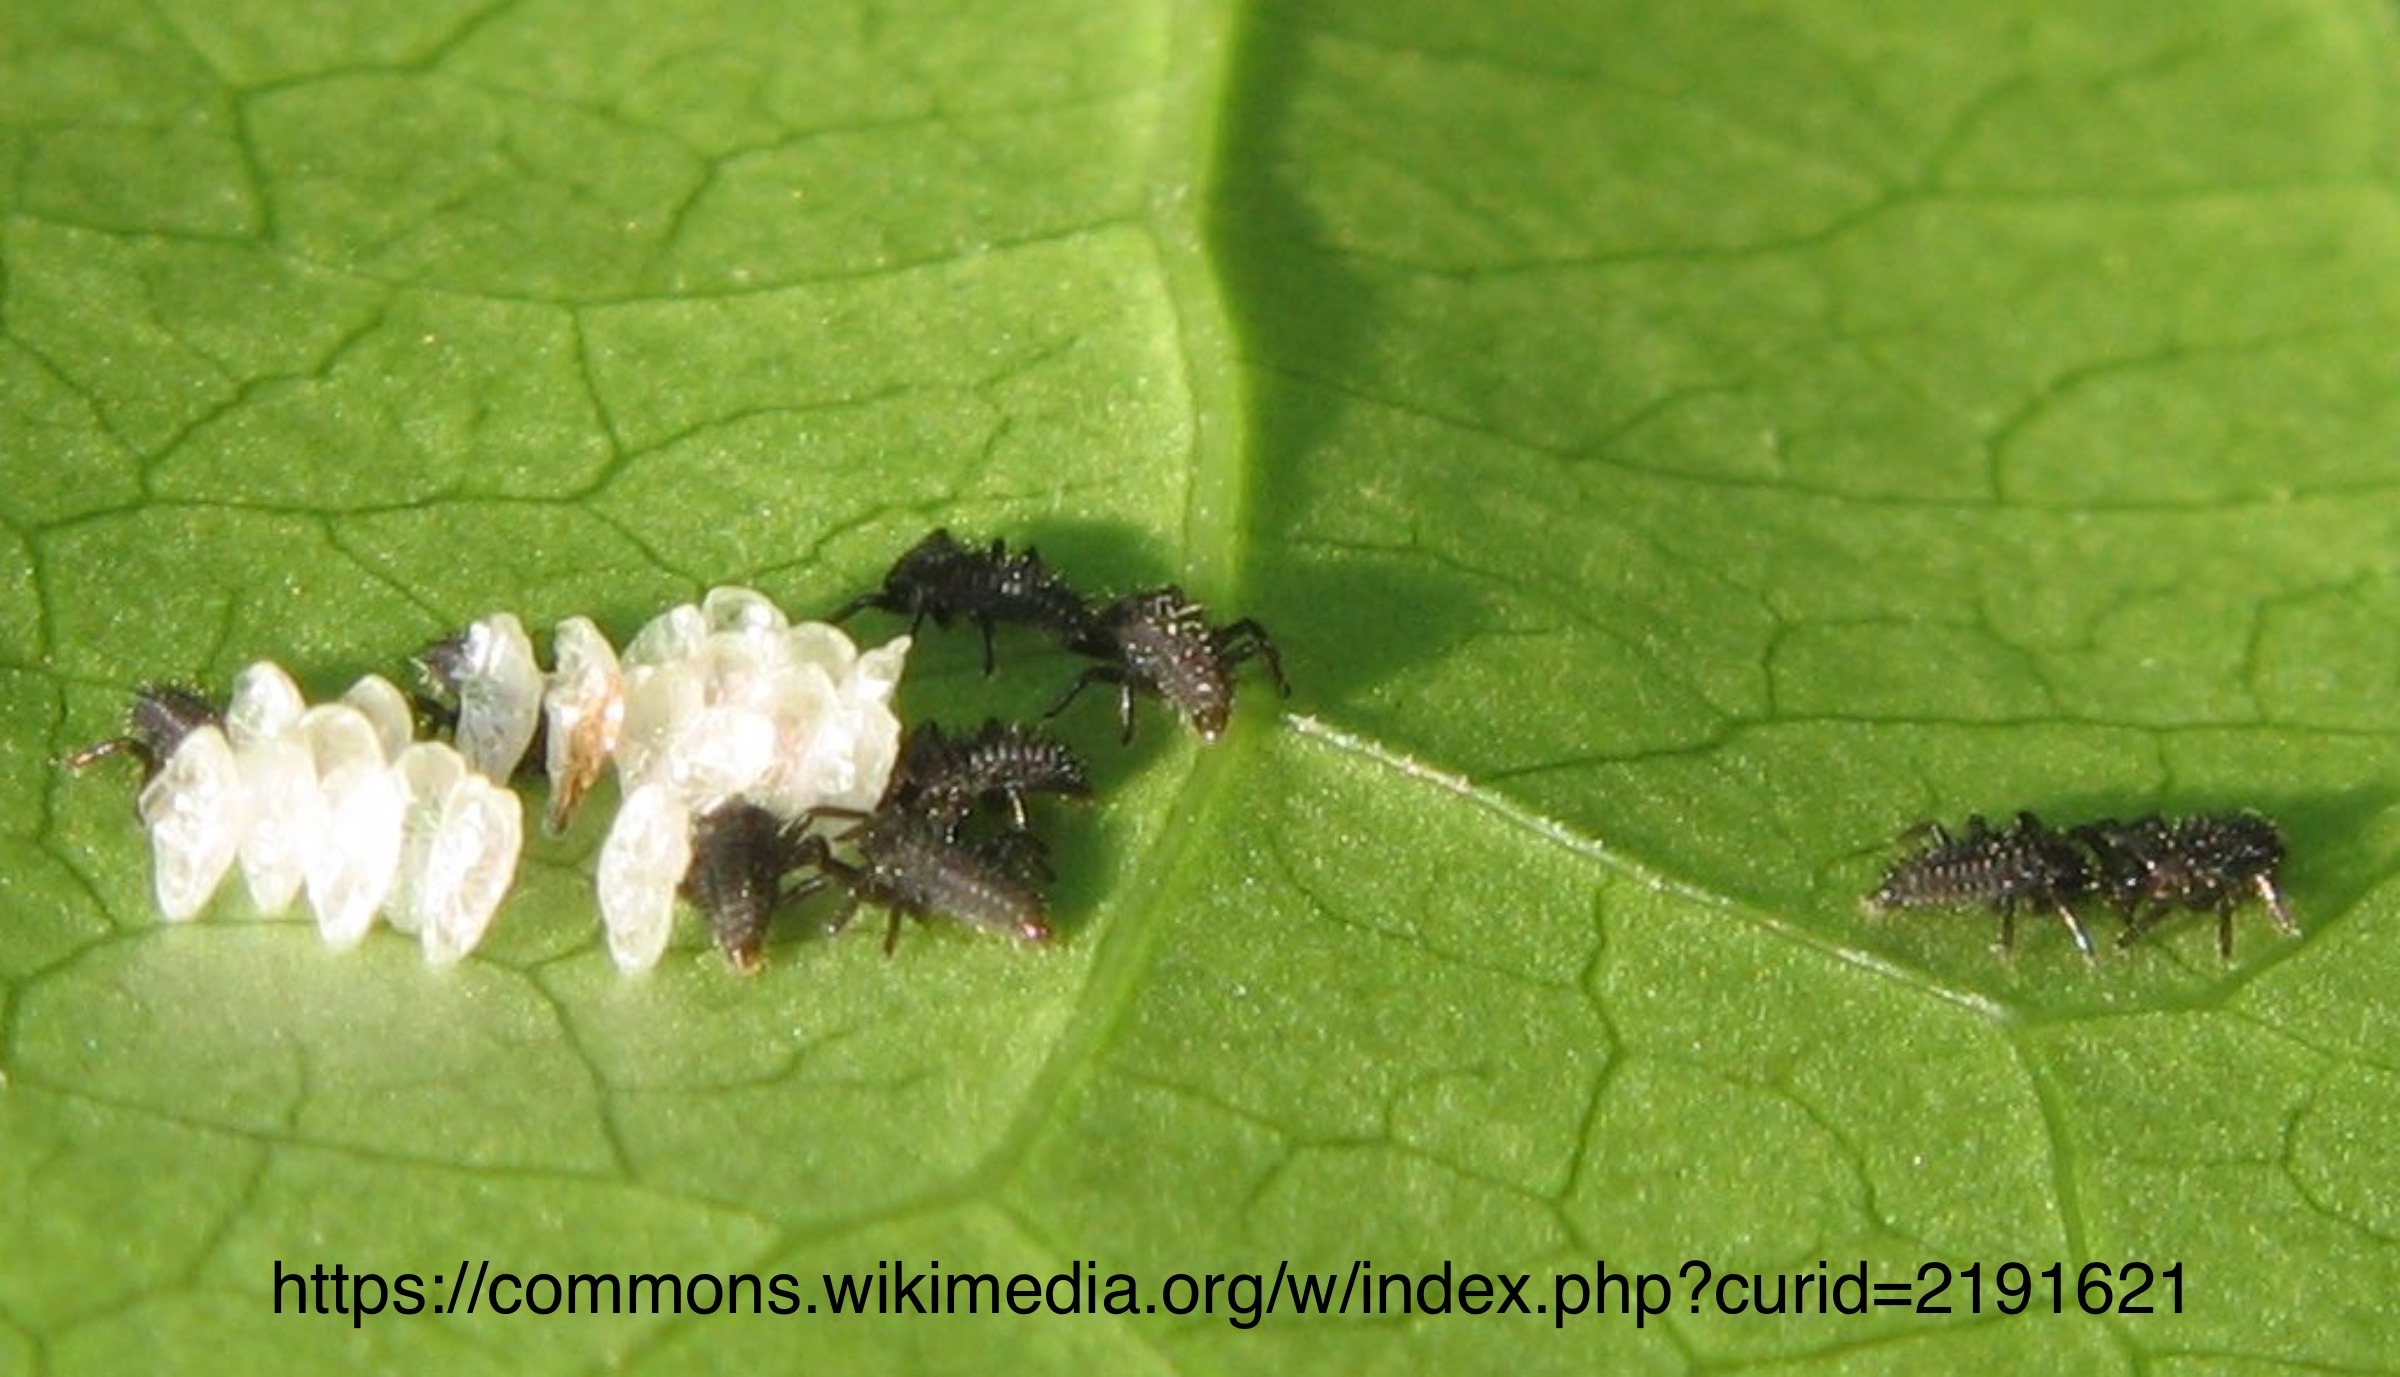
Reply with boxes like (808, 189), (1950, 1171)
(1867, 813), (2299, 960)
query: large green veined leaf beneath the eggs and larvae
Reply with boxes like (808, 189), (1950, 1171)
(0, 0), (2400, 1375)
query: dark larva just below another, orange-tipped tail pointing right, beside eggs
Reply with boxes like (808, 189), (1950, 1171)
(792, 808), (1051, 955)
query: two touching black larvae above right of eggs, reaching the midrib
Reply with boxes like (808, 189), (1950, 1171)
(833, 530), (1291, 741)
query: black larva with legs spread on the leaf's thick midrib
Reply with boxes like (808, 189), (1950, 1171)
(1049, 585), (1291, 741)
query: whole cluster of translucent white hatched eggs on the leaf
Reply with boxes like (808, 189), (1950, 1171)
(110, 588), (910, 972)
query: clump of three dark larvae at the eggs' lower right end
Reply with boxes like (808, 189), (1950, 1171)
(684, 722), (1092, 972)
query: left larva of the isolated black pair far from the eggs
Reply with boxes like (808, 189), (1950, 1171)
(1867, 813), (2093, 957)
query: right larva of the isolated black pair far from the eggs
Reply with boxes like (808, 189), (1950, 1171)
(2074, 813), (2299, 962)
